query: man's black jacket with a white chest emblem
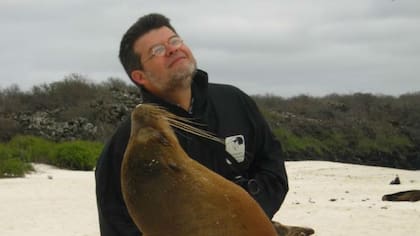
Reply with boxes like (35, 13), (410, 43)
(95, 70), (288, 236)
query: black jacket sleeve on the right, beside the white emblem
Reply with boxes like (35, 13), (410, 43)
(244, 91), (289, 218)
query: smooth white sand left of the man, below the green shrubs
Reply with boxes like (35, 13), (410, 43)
(0, 164), (99, 236)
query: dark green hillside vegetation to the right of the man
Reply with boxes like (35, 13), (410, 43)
(254, 93), (420, 169)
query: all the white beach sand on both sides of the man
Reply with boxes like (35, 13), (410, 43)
(0, 161), (420, 236)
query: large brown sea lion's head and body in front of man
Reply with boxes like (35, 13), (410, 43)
(121, 104), (277, 236)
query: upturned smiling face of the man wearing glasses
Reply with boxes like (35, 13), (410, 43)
(131, 27), (196, 96)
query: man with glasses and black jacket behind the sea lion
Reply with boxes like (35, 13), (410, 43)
(95, 14), (288, 236)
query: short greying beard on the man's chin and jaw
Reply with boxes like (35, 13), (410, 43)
(146, 60), (197, 93)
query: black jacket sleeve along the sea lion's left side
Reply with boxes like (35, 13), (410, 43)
(95, 121), (142, 236)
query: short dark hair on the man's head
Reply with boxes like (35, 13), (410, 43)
(119, 13), (176, 79)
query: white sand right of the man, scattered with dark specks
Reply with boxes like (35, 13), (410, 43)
(274, 161), (420, 236)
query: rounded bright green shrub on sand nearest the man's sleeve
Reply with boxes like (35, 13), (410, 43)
(53, 141), (102, 170)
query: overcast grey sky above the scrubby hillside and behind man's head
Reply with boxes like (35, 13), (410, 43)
(0, 0), (420, 97)
